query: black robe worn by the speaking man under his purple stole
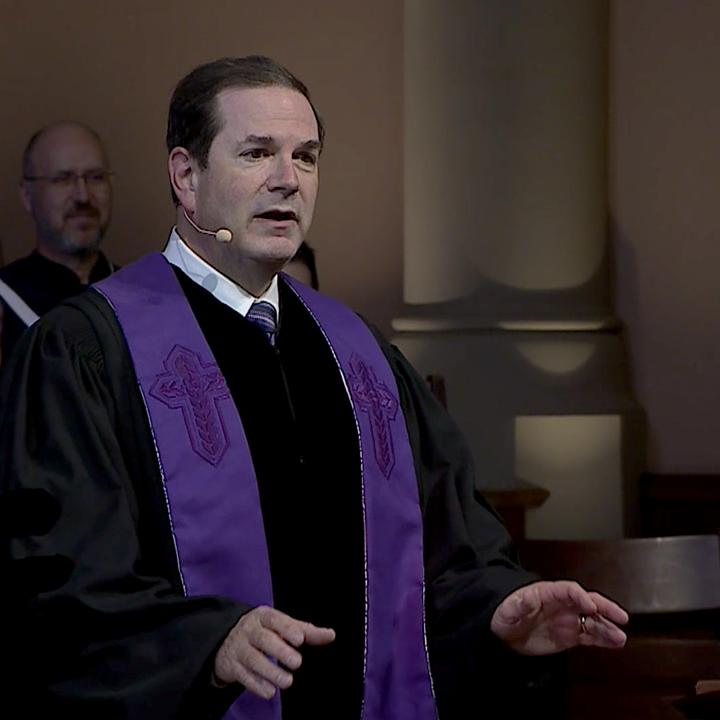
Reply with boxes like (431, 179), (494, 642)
(0, 271), (534, 720)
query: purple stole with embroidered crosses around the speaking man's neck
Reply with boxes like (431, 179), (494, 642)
(94, 253), (437, 720)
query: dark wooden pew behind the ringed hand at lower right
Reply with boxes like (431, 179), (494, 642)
(520, 535), (720, 720)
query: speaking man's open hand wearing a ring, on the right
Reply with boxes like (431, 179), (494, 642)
(490, 580), (628, 655)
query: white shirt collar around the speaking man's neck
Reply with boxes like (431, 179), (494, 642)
(163, 228), (280, 319)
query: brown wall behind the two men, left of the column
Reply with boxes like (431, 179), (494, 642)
(0, 0), (402, 329)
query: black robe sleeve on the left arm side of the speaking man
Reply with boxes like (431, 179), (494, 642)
(0, 293), (248, 720)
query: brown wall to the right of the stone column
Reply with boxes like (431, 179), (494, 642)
(610, 0), (720, 473)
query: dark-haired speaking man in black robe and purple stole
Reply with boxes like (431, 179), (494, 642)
(0, 57), (627, 720)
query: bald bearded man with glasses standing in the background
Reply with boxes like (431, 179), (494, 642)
(0, 122), (112, 366)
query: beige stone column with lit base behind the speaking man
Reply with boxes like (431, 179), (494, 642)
(400, 0), (642, 537)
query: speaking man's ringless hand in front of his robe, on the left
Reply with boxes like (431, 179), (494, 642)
(214, 605), (335, 700)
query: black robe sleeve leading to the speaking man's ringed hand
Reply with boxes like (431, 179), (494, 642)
(376, 333), (564, 719)
